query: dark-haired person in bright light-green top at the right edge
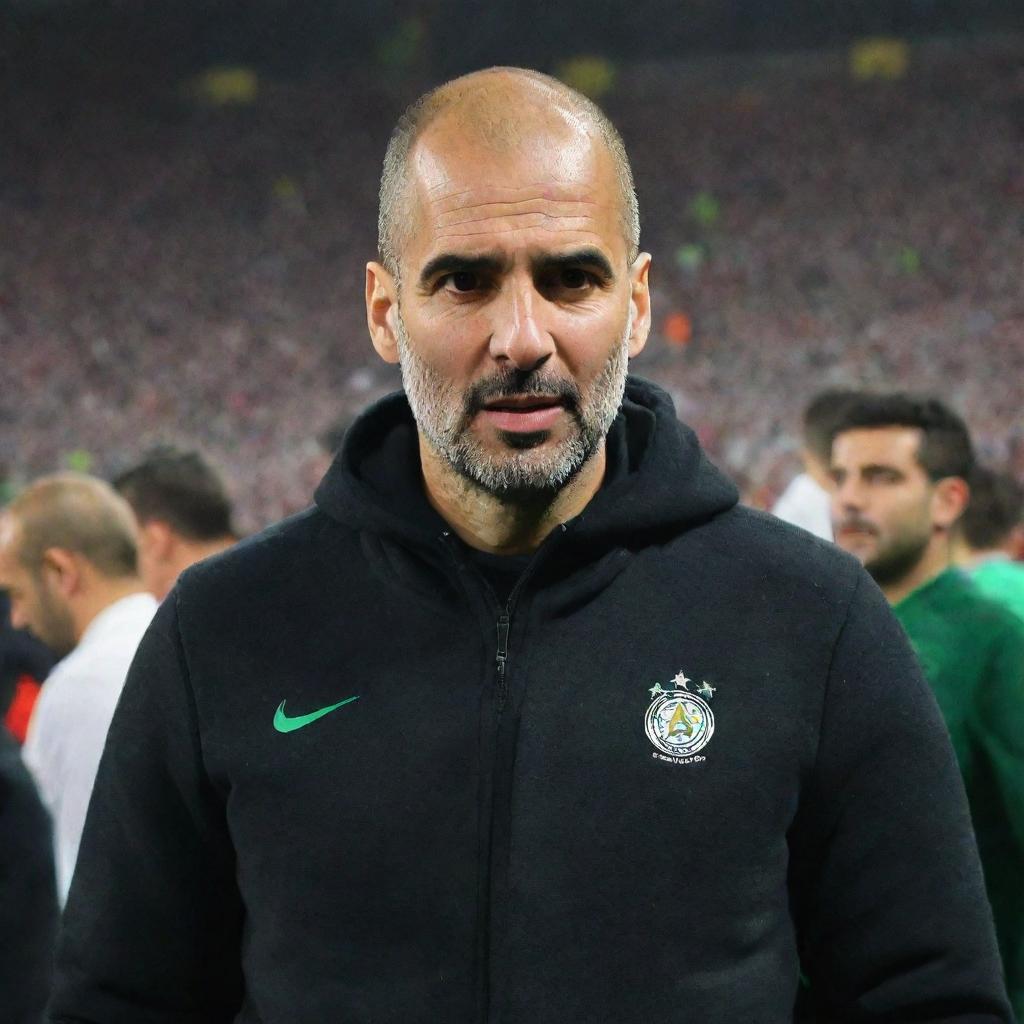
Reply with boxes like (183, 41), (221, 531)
(953, 466), (1024, 618)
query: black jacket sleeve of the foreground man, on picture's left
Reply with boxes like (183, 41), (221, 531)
(48, 593), (242, 1024)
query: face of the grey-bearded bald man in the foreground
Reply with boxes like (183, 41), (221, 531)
(374, 114), (649, 496)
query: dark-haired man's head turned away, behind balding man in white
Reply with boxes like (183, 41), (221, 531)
(114, 447), (238, 601)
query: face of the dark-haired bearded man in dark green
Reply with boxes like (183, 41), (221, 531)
(831, 427), (936, 586)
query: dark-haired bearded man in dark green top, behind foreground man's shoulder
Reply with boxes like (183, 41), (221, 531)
(831, 394), (1024, 1014)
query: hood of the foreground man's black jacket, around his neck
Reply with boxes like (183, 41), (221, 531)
(315, 377), (738, 547)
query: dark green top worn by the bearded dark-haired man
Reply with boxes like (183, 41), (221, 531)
(893, 568), (1024, 1020)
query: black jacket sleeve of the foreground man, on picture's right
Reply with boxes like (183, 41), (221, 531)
(790, 573), (1013, 1024)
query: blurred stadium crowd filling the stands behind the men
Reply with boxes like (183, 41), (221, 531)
(0, 38), (1024, 530)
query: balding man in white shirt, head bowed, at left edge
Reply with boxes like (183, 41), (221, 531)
(0, 473), (157, 903)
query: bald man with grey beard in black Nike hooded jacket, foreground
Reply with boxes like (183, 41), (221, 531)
(51, 69), (1010, 1024)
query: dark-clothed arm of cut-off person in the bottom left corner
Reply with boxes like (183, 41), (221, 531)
(0, 729), (57, 1024)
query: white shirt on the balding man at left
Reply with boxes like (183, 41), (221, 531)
(22, 594), (157, 905)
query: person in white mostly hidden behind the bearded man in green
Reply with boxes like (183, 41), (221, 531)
(772, 389), (857, 541)
